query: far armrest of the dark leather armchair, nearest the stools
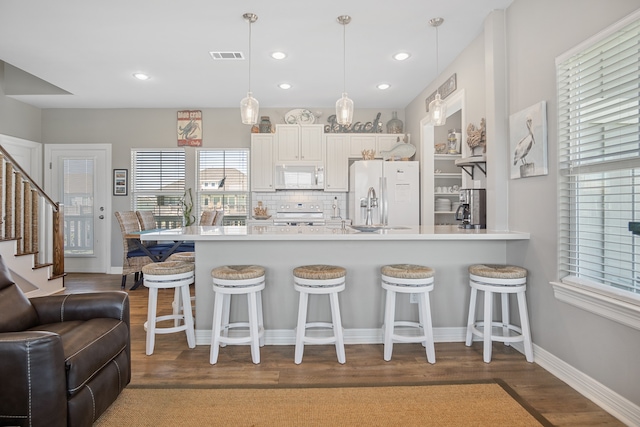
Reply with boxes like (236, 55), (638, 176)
(30, 291), (129, 326)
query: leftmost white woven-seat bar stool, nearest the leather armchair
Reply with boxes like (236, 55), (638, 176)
(142, 261), (196, 355)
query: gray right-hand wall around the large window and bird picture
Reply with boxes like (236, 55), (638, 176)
(405, 0), (640, 405)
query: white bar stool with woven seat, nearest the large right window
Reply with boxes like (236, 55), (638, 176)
(465, 264), (533, 363)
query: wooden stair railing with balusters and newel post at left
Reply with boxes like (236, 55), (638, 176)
(0, 146), (64, 278)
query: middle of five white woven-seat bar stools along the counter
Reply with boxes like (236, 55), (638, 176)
(293, 265), (347, 365)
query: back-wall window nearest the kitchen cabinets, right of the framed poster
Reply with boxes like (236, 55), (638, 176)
(197, 150), (250, 225)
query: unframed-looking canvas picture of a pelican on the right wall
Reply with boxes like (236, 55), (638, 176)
(509, 101), (549, 179)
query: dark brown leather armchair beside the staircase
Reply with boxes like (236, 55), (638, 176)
(0, 257), (131, 427)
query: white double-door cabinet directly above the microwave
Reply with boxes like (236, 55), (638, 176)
(275, 125), (324, 162)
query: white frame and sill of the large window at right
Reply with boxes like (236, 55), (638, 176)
(551, 12), (640, 330)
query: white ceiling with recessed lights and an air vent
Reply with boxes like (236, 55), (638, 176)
(0, 0), (512, 109)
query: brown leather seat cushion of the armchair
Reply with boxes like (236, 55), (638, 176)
(32, 318), (129, 396)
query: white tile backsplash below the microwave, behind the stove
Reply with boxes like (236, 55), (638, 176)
(251, 190), (347, 219)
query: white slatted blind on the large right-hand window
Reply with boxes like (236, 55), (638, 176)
(556, 18), (640, 293)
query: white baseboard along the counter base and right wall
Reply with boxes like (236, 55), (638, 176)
(195, 327), (640, 426)
